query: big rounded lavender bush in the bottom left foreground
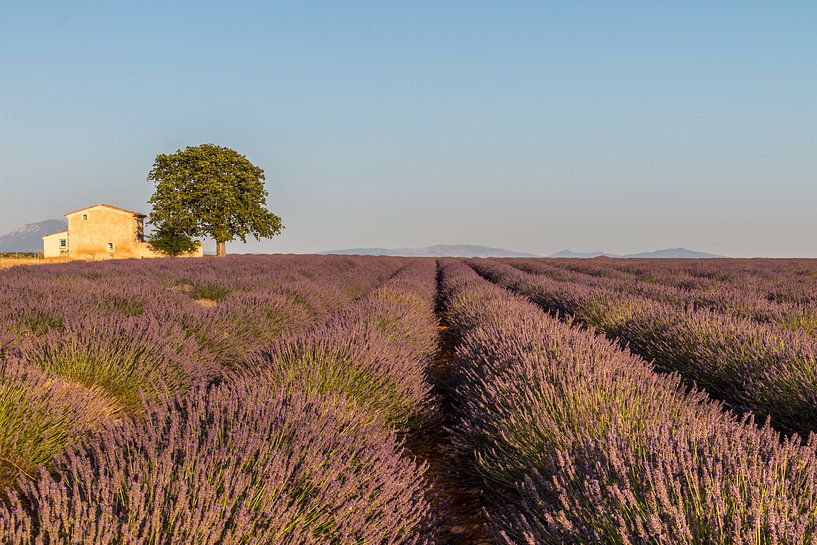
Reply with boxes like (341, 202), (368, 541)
(0, 382), (431, 545)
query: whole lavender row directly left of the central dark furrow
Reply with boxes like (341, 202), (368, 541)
(0, 260), (437, 545)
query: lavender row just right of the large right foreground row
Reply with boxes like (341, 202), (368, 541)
(473, 261), (817, 434)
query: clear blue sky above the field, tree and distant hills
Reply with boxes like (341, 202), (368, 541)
(0, 1), (817, 256)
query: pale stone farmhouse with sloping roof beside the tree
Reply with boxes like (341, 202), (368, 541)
(43, 204), (203, 259)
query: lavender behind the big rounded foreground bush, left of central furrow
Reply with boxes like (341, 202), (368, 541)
(248, 261), (437, 429)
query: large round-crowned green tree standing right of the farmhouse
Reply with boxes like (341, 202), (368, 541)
(148, 144), (283, 256)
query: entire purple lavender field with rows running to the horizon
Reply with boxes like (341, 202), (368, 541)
(0, 255), (817, 545)
